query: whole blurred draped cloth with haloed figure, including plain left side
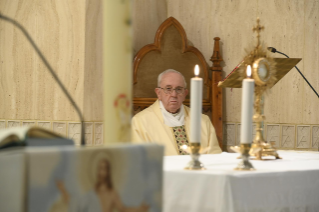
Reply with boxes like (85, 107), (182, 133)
(0, 144), (164, 212)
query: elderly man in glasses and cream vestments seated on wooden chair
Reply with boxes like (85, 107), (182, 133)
(132, 69), (221, 155)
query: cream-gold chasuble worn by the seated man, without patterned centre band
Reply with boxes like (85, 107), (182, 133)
(132, 100), (221, 155)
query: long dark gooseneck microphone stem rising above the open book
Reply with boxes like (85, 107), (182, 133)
(0, 13), (85, 146)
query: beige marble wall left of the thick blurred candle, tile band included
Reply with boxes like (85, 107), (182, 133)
(0, 0), (103, 143)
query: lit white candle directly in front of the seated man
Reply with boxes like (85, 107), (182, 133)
(190, 65), (203, 143)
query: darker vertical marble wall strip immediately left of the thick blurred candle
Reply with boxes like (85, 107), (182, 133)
(83, 0), (103, 121)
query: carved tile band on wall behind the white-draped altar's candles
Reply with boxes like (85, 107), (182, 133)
(224, 123), (319, 151)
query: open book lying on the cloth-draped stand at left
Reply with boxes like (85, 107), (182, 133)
(0, 126), (73, 149)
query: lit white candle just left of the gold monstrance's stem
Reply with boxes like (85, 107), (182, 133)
(240, 65), (255, 144)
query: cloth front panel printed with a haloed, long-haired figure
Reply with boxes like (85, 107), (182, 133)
(28, 146), (163, 212)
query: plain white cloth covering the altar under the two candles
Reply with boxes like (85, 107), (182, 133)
(164, 151), (319, 212)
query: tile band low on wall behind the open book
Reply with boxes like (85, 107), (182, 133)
(0, 120), (103, 146)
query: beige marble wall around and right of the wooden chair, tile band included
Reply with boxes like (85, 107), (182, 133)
(133, 0), (319, 149)
